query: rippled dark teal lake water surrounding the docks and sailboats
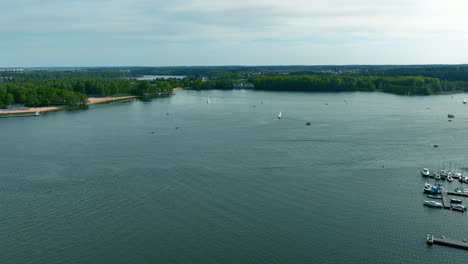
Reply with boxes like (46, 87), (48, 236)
(0, 91), (468, 264)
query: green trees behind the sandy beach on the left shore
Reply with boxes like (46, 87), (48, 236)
(0, 78), (180, 107)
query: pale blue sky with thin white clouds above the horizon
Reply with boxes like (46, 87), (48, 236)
(0, 0), (468, 67)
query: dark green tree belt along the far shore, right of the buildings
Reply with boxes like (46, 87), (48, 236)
(251, 75), (442, 94)
